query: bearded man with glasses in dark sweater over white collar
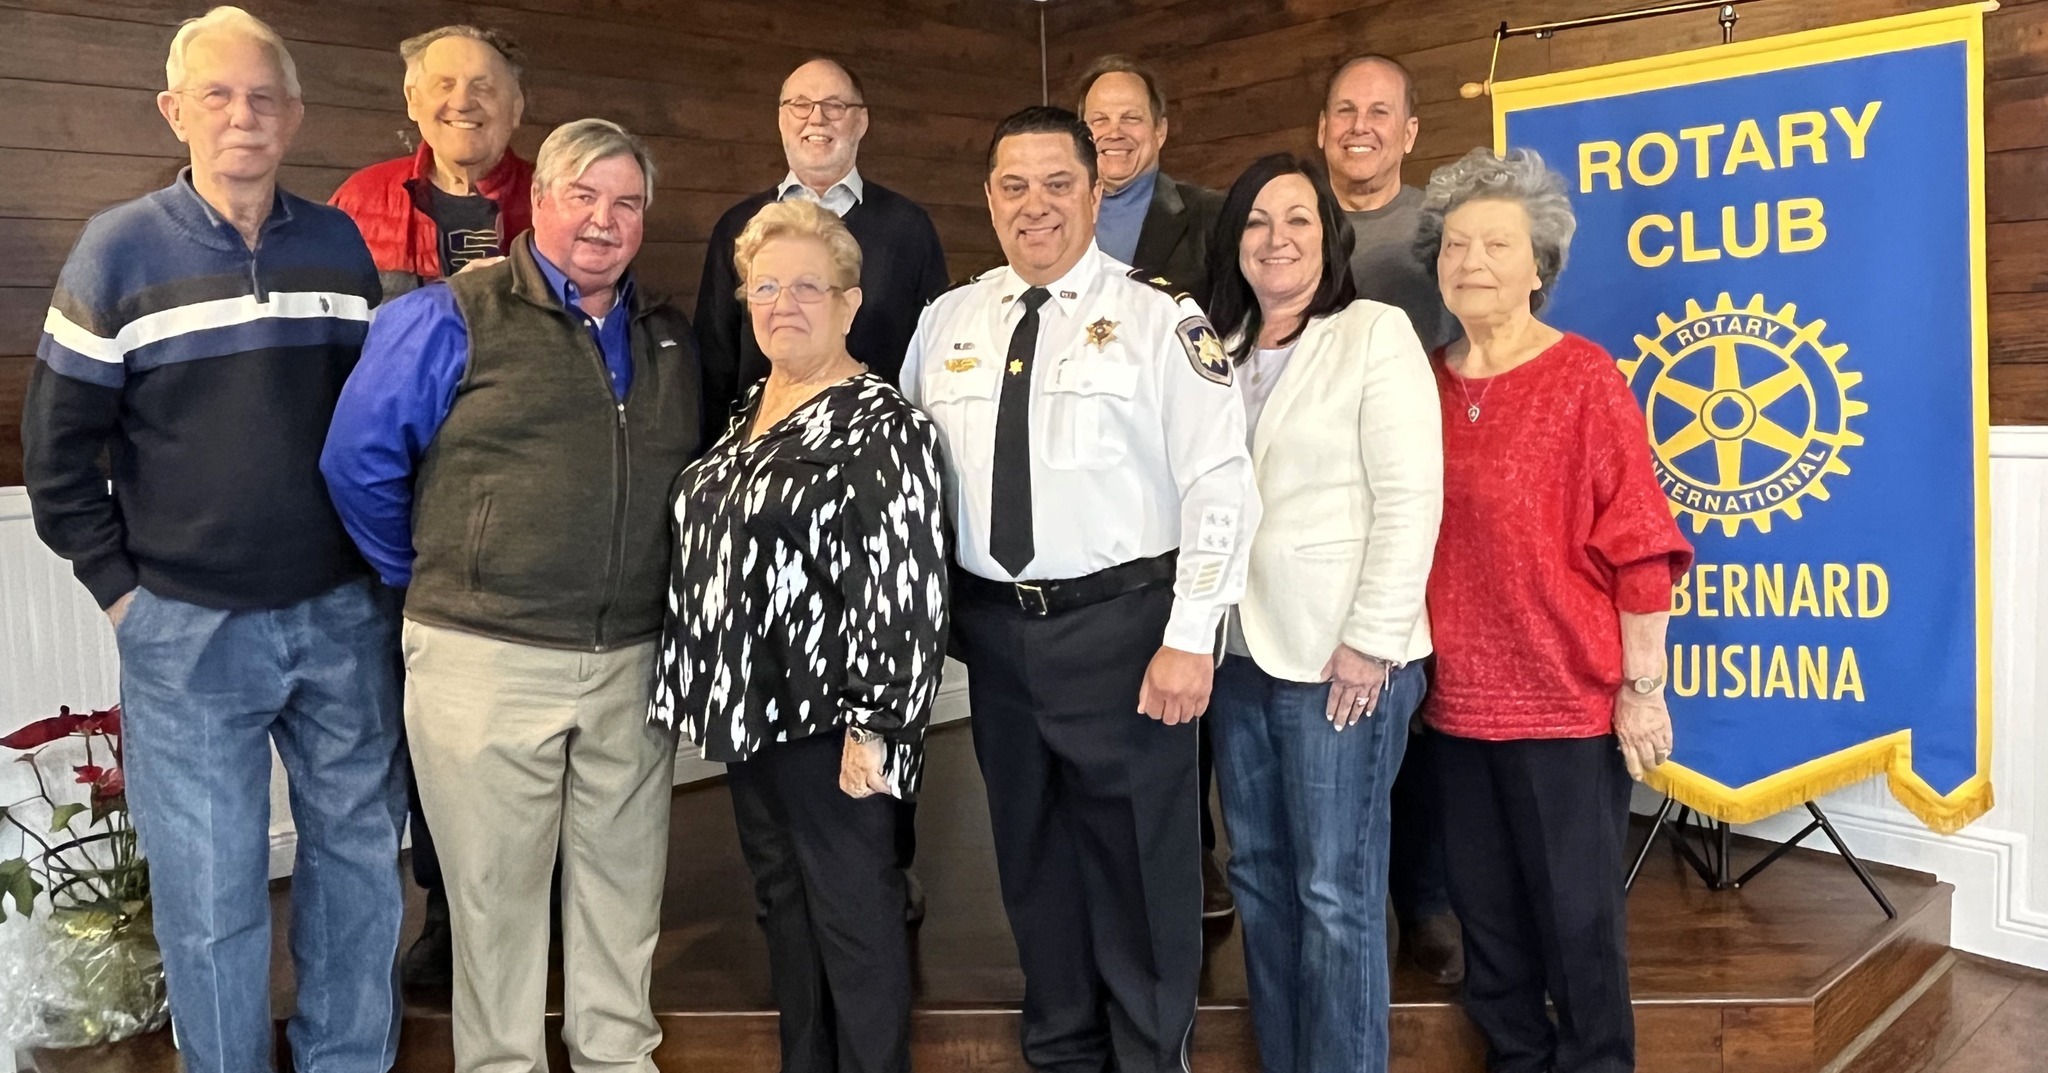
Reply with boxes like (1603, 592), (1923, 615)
(696, 59), (946, 924)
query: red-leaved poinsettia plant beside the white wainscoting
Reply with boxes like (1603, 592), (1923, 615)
(0, 704), (150, 921)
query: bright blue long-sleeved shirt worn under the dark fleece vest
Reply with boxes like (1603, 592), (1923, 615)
(319, 252), (633, 588)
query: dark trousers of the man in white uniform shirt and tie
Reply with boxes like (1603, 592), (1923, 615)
(952, 586), (1202, 1073)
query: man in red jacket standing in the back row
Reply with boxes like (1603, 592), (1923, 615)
(330, 27), (532, 301)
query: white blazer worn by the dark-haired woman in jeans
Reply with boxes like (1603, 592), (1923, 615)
(1237, 299), (1444, 682)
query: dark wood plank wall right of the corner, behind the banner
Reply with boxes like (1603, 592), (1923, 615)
(1051, 0), (2048, 424)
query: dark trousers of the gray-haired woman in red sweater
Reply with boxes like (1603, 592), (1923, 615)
(1432, 735), (1636, 1073)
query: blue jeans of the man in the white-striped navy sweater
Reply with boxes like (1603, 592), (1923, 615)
(115, 582), (406, 1073)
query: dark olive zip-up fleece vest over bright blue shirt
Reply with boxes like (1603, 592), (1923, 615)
(406, 233), (705, 651)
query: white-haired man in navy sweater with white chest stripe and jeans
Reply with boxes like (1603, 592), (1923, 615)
(23, 8), (406, 1073)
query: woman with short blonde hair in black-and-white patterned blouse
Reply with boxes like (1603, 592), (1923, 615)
(653, 201), (946, 1073)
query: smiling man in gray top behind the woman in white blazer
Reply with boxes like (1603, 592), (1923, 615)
(1315, 55), (1456, 350)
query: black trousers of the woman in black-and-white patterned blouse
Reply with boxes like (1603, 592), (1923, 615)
(725, 731), (911, 1073)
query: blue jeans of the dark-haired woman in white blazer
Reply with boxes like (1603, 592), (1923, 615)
(1208, 655), (1423, 1073)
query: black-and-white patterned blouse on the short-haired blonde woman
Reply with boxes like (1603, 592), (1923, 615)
(649, 373), (946, 797)
